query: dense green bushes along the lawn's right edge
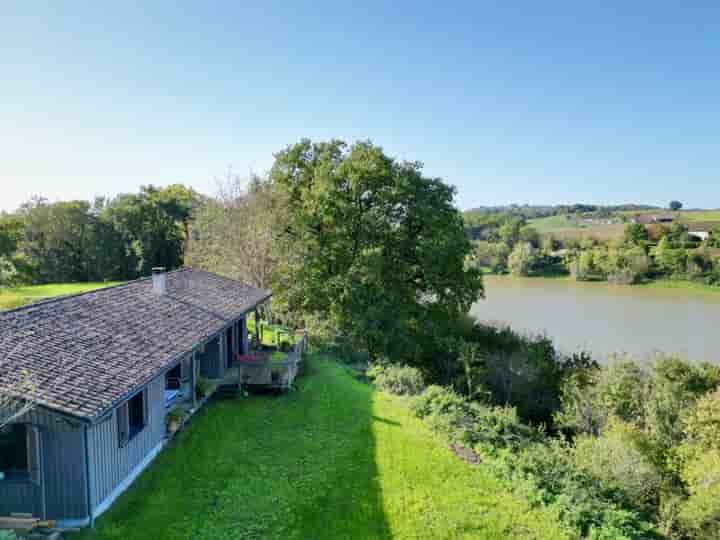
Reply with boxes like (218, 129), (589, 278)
(367, 344), (720, 540)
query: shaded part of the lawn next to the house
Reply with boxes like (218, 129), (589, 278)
(72, 358), (396, 540)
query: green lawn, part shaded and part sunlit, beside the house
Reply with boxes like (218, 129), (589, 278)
(73, 357), (564, 540)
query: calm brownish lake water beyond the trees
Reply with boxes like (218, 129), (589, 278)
(472, 276), (720, 363)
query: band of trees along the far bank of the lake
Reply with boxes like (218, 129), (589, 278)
(467, 213), (720, 284)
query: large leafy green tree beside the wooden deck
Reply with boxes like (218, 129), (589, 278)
(270, 140), (483, 362)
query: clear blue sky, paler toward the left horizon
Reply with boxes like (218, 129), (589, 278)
(0, 0), (720, 209)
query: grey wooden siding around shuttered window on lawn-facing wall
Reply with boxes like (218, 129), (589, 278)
(88, 373), (166, 509)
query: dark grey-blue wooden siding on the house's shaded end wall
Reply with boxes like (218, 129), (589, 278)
(0, 408), (87, 519)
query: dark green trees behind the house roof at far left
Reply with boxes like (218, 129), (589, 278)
(0, 185), (201, 286)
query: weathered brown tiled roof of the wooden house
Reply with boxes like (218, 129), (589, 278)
(0, 268), (270, 419)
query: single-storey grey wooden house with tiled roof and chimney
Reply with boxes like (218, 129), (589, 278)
(0, 268), (271, 527)
